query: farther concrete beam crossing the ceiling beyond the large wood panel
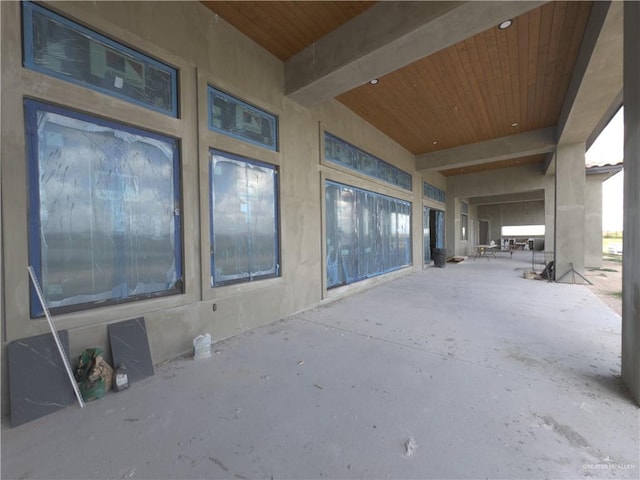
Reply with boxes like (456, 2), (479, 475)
(416, 127), (557, 171)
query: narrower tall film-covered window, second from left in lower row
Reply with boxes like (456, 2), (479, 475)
(209, 150), (280, 287)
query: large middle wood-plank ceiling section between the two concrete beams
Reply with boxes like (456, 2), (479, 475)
(338, 2), (591, 154)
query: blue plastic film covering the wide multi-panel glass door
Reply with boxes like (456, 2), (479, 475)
(325, 181), (411, 288)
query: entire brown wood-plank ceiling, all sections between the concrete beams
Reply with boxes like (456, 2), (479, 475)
(203, 1), (591, 175)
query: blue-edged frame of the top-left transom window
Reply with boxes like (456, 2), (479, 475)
(22, 1), (179, 118)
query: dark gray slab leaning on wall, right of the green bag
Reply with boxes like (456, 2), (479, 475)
(108, 317), (154, 383)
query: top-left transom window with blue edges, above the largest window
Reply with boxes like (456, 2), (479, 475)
(23, 2), (178, 117)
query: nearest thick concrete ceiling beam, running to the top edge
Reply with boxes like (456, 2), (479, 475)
(284, 1), (546, 107)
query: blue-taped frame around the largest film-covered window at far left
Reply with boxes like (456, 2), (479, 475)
(23, 97), (185, 319)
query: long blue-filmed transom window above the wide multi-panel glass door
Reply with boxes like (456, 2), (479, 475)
(324, 132), (413, 191)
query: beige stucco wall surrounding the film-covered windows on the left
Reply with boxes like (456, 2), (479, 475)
(1, 2), (422, 413)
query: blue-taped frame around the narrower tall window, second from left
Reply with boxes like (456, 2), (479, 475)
(207, 147), (282, 289)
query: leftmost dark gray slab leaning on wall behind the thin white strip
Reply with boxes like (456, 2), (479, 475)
(7, 330), (75, 427)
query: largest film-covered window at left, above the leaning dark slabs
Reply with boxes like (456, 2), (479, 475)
(25, 100), (183, 317)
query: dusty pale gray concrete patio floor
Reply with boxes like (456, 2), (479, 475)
(2, 253), (640, 479)
